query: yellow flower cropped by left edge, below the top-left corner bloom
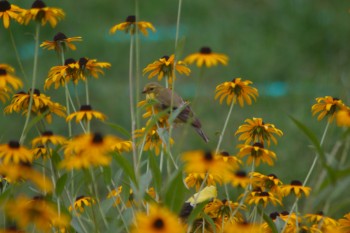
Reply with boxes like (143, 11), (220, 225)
(0, 64), (23, 90)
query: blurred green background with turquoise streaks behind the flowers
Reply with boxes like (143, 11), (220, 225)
(0, 0), (350, 213)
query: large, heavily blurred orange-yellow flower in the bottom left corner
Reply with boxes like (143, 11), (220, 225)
(5, 196), (70, 232)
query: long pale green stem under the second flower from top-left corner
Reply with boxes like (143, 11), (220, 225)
(19, 23), (40, 144)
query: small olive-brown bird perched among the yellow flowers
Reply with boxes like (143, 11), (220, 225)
(142, 82), (209, 142)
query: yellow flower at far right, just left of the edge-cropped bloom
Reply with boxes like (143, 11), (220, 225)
(311, 96), (344, 122)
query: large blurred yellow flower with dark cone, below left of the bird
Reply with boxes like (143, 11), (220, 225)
(60, 133), (119, 170)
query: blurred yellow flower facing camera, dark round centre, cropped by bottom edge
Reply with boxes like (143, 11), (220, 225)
(131, 204), (185, 233)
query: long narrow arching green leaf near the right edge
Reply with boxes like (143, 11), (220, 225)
(289, 116), (336, 183)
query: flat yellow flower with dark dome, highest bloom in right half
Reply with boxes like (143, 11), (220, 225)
(184, 47), (228, 68)
